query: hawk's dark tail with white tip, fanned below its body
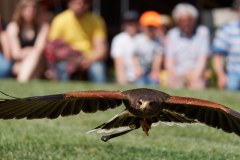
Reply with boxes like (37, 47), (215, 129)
(88, 110), (140, 141)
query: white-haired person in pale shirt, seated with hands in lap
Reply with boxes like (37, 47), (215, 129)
(165, 3), (210, 89)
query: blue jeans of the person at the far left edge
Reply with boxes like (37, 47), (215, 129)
(0, 52), (12, 78)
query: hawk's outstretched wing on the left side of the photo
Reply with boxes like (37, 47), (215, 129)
(0, 91), (124, 119)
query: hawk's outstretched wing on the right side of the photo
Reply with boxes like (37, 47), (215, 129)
(164, 96), (240, 136)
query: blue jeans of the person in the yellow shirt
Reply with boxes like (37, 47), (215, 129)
(55, 61), (106, 83)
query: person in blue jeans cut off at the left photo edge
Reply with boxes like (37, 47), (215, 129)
(0, 16), (12, 78)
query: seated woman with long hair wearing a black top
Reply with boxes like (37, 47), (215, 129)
(7, 0), (49, 82)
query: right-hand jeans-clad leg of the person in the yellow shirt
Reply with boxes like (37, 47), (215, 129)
(87, 62), (106, 83)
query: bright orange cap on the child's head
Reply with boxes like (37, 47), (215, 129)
(139, 11), (161, 27)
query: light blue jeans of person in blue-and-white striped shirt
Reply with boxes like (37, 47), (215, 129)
(226, 72), (240, 91)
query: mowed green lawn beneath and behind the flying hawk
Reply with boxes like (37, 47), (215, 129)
(0, 80), (240, 160)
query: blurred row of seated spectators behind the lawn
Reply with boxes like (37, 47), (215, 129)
(0, 0), (240, 90)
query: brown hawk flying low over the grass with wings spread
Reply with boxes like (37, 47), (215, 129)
(0, 88), (240, 141)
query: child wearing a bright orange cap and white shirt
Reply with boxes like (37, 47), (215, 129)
(134, 11), (163, 85)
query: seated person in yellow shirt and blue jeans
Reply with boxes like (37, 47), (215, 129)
(47, 0), (107, 83)
